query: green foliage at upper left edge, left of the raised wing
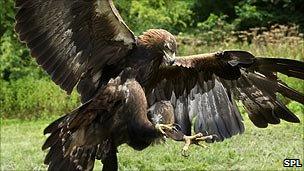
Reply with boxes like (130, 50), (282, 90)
(0, 0), (44, 81)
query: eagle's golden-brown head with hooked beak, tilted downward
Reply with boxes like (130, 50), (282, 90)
(138, 29), (177, 65)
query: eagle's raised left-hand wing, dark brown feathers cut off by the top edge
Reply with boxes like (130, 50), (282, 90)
(15, 0), (135, 99)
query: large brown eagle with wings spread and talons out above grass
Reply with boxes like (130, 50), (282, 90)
(15, 0), (304, 170)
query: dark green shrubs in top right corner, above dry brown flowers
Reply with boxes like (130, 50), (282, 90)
(234, 0), (304, 31)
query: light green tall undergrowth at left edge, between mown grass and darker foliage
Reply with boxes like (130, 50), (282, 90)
(0, 76), (80, 119)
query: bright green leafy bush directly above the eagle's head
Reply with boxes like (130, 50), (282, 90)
(117, 0), (192, 34)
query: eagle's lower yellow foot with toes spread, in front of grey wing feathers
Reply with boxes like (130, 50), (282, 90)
(182, 133), (217, 157)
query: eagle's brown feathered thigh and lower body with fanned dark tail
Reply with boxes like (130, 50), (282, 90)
(42, 69), (164, 170)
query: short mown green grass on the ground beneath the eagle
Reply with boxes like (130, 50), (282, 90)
(1, 104), (304, 170)
